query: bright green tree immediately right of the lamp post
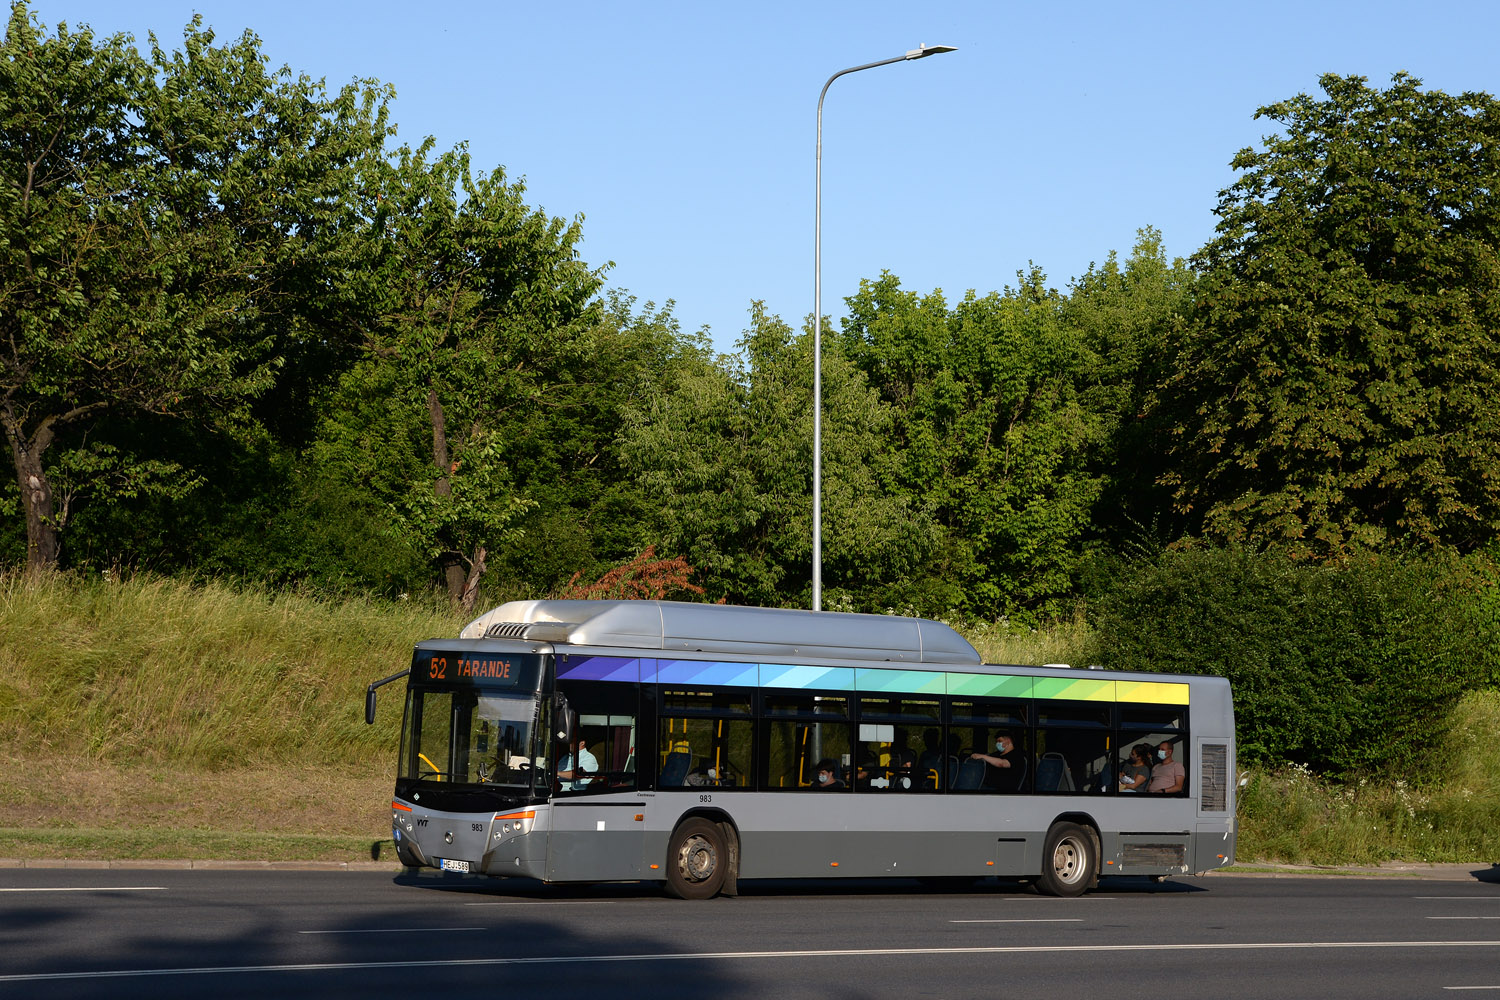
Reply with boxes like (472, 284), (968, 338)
(842, 268), (1106, 616)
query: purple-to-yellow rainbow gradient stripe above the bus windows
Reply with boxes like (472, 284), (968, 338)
(558, 655), (1188, 705)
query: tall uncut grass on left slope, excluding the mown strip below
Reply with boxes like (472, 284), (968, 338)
(0, 574), (459, 771)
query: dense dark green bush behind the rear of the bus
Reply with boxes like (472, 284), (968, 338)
(1095, 549), (1500, 777)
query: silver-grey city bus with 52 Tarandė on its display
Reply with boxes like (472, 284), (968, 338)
(366, 601), (1236, 898)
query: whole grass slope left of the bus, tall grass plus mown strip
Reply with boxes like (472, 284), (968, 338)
(0, 574), (459, 859)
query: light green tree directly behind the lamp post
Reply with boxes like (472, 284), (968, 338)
(621, 303), (938, 609)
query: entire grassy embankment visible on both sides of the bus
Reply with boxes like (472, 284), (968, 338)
(0, 574), (1500, 865)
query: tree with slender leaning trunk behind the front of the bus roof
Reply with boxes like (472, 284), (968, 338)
(309, 139), (600, 609)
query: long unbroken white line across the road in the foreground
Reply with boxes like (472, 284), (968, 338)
(0, 942), (1500, 982)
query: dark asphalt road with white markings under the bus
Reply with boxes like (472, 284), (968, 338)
(0, 870), (1500, 1000)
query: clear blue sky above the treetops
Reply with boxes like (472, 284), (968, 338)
(20, 0), (1500, 349)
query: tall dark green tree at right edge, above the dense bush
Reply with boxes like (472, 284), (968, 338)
(1157, 73), (1500, 558)
